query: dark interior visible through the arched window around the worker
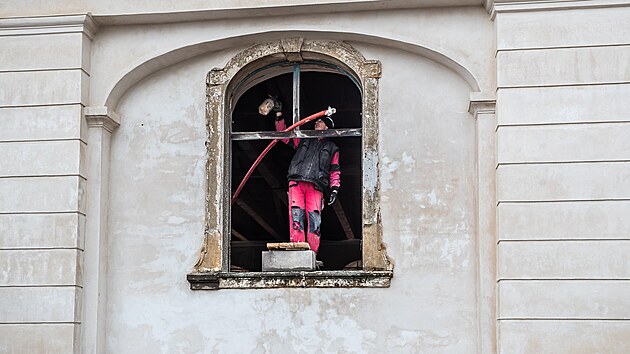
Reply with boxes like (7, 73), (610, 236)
(230, 71), (362, 271)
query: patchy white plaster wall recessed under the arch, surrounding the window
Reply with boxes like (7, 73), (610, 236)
(107, 43), (477, 353)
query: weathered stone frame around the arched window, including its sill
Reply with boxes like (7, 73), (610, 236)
(187, 38), (393, 290)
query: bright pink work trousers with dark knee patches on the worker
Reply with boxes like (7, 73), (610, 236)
(289, 181), (324, 253)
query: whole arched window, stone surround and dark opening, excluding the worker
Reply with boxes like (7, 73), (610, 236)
(187, 38), (393, 290)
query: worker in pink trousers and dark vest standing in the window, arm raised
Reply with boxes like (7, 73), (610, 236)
(259, 97), (341, 256)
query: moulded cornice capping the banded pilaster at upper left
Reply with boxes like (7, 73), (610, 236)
(0, 13), (98, 39)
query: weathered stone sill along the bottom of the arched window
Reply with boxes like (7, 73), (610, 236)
(187, 270), (394, 290)
